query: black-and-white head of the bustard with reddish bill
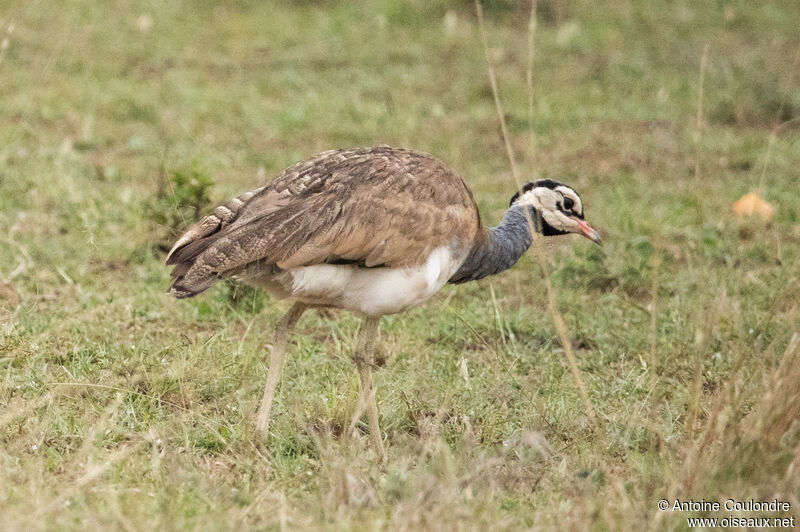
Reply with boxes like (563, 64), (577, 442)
(509, 179), (602, 244)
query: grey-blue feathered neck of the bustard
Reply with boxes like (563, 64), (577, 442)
(448, 205), (541, 284)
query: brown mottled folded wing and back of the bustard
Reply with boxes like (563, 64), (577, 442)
(168, 147), (480, 297)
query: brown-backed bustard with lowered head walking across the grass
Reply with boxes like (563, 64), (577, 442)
(166, 145), (601, 462)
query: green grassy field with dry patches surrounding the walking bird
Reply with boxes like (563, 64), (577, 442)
(0, 0), (800, 530)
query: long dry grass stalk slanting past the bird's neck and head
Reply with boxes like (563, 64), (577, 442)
(475, 0), (596, 422)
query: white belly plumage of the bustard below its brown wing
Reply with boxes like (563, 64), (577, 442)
(275, 247), (464, 316)
